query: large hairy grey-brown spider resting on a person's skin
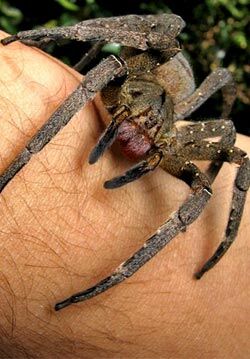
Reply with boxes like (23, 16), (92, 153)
(0, 14), (250, 310)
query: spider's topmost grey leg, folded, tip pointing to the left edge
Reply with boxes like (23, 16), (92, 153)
(1, 14), (185, 50)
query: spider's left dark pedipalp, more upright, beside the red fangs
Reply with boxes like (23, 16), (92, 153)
(89, 105), (129, 164)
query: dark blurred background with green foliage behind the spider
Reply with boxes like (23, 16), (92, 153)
(0, 0), (250, 135)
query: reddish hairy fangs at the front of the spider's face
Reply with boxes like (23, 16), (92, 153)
(117, 120), (152, 160)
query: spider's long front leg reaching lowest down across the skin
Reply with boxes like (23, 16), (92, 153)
(55, 161), (211, 310)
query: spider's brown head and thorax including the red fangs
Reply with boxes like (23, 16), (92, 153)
(99, 50), (173, 160)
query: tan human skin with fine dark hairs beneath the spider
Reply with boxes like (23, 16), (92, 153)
(0, 33), (250, 359)
